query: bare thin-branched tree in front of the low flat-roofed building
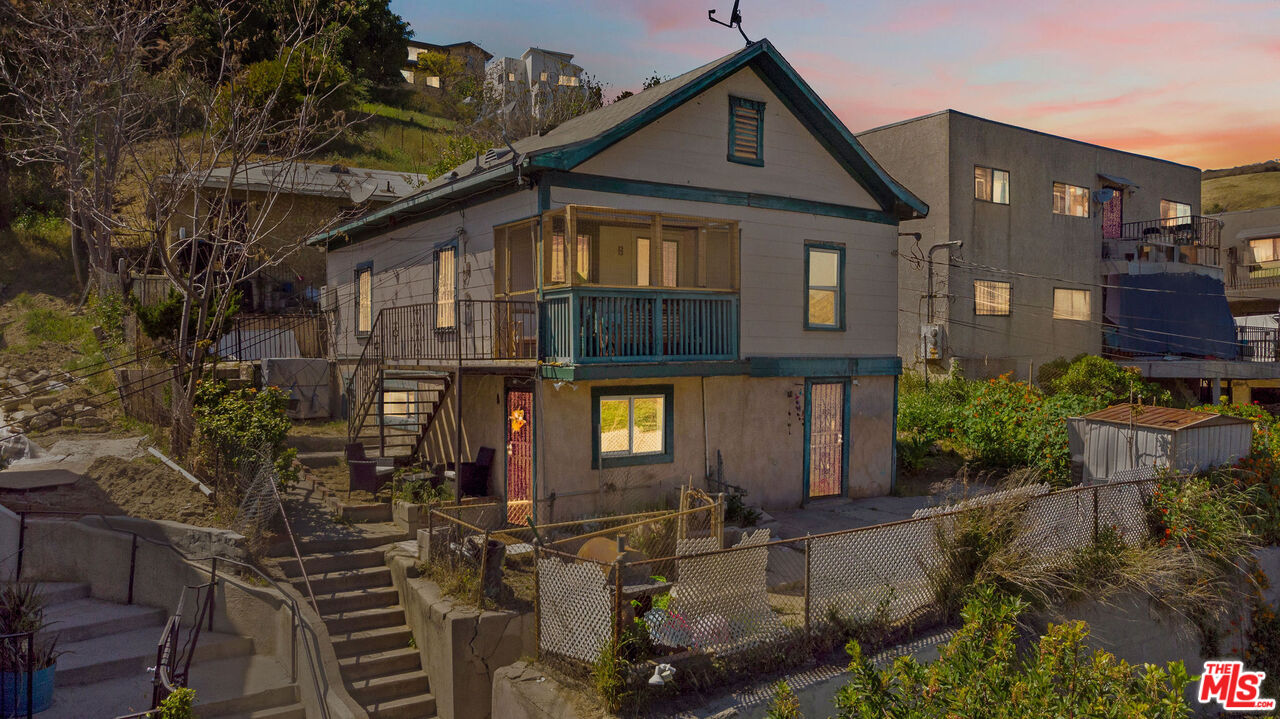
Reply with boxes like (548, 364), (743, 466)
(124, 0), (353, 452)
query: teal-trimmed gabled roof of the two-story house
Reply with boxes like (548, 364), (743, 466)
(307, 40), (929, 244)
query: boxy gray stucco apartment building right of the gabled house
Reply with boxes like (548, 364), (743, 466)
(858, 110), (1253, 394)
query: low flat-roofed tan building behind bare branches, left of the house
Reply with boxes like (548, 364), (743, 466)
(166, 162), (426, 312)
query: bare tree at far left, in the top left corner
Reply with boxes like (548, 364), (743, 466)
(0, 0), (182, 284)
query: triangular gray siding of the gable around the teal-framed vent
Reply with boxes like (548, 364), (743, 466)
(575, 69), (879, 210)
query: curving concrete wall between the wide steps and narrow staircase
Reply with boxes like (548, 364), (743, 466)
(22, 518), (367, 719)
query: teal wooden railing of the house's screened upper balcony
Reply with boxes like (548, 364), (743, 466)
(540, 287), (737, 365)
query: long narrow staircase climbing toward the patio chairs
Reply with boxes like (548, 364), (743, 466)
(276, 481), (435, 719)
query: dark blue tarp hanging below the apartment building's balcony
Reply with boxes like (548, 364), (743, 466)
(1103, 273), (1240, 360)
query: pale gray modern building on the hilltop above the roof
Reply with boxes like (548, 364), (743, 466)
(485, 47), (586, 118)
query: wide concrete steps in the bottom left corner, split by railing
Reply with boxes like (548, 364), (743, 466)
(31, 582), (306, 719)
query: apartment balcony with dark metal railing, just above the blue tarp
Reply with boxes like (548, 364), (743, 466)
(1102, 215), (1222, 271)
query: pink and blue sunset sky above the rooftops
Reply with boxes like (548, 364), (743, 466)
(392, 0), (1280, 168)
